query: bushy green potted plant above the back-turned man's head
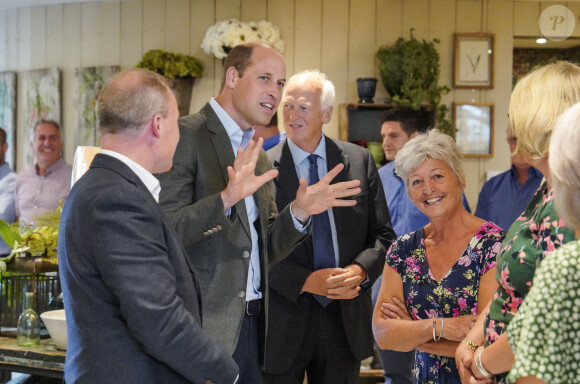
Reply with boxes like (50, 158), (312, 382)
(136, 49), (203, 116)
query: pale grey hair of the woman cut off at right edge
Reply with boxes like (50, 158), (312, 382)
(548, 103), (580, 229)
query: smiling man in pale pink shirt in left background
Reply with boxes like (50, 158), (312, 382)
(14, 119), (72, 223)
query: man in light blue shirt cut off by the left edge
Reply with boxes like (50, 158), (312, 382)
(0, 128), (16, 256)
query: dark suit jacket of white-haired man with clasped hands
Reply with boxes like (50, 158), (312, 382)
(265, 137), (396, 374)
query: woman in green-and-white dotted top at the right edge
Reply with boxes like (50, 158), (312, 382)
(507, 100), (580, 384)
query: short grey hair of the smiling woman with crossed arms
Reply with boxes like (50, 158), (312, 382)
(395, 129), (465, 191)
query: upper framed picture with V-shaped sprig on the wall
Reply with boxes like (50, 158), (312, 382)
(453, 33), (495, 89)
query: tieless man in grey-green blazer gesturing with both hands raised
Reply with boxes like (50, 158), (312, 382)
(158, 43), (360, 384)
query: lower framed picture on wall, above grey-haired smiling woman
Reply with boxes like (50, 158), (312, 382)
(453, 103), (493, 157)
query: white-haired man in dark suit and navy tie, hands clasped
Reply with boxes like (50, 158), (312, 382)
(263, 71), (395, 384)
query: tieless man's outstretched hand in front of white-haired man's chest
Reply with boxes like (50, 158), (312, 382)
(292, 164), (361, 220)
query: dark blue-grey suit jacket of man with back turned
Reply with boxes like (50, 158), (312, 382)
(58, 154), (238, 384)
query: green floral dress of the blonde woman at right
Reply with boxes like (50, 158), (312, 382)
(484, 180), (574, 383)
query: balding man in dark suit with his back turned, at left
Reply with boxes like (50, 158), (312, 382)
(58, 70), (238, 384)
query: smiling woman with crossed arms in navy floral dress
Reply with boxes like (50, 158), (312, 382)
(373, 130), (504, 384)
